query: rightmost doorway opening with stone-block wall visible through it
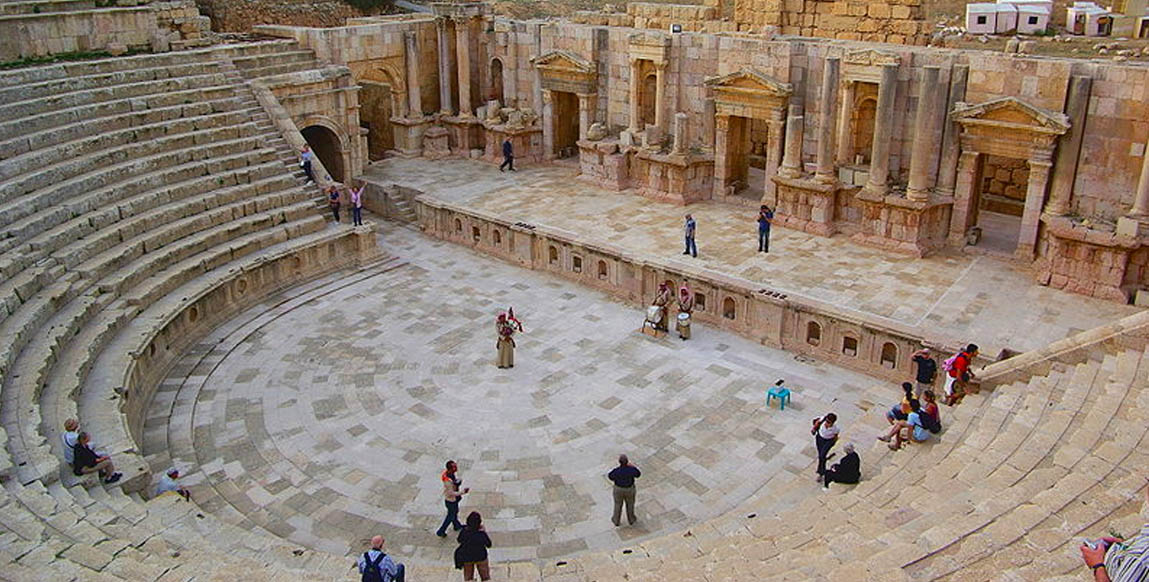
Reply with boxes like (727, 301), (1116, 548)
(972, 155), (1030, 256)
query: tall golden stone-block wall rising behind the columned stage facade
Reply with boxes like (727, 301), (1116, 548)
(734, 0), (933, 45)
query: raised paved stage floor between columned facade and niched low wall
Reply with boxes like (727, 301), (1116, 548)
(365, 158), (1138, 356)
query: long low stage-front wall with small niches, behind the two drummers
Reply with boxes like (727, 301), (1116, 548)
(415, 194), (974, 381)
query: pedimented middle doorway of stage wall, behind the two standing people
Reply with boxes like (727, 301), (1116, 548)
(705, 69), (794, 204)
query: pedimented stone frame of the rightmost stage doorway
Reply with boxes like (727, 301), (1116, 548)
(949, 98), (1070, 261)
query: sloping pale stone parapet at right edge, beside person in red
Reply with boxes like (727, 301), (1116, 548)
(977, 311), (1149, 387)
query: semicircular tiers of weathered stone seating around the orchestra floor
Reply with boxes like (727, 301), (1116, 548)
(0, 42), (1149, 582)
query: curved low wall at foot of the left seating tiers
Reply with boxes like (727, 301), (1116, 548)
(121, 227), (379, 443)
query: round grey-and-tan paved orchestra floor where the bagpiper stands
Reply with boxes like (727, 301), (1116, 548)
(147, 231), (872, 561)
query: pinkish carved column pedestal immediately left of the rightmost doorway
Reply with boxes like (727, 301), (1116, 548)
(853, 191), (954, 257)
